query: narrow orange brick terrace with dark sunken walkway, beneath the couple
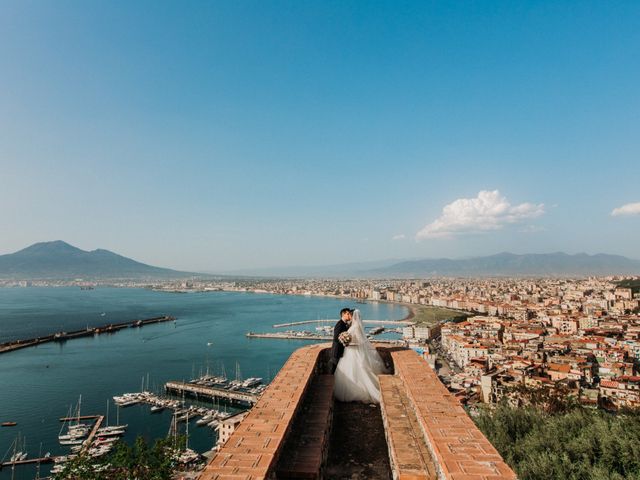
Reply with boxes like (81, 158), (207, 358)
(200, 345), (516, 480)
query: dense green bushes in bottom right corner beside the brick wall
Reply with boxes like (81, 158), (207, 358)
(475, 404), (640, 480)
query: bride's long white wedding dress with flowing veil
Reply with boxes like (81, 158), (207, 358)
(334, 310), (386, 403)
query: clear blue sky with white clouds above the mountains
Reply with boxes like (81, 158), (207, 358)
(0, 1), (640, 271)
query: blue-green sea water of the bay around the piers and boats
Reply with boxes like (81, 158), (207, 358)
(0, 287), (408, 480)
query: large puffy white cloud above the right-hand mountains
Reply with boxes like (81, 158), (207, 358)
(416, 190), (544, 240)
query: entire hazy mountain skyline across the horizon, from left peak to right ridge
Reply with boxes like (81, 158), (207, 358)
(0, 240), (640, 279)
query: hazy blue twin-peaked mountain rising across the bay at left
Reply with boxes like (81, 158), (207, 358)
(0, 240), (188, 279)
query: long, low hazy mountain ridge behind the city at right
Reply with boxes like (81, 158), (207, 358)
(360, 252), (640, 278)
